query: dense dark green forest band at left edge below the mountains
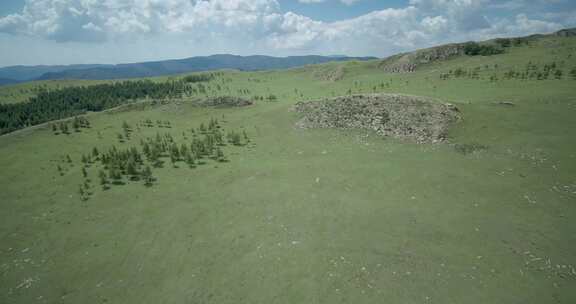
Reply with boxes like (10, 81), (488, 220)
(0, 80), (194, 134)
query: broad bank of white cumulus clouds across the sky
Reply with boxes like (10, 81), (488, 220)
(0, 0), (576, 61)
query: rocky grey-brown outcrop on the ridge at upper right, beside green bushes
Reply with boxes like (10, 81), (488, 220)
(379, 44), (464, 73)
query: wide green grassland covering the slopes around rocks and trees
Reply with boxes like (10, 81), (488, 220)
(0, 34), (576, 304)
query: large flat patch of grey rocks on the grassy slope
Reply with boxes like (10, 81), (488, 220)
(294, 94), (461, 143)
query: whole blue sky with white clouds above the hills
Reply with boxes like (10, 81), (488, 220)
(0, 0), (576, 66)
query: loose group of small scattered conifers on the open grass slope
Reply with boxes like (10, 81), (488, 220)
(62, 118), (250, 201)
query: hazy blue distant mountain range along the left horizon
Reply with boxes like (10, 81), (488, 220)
(0, 55), (377, 85)
